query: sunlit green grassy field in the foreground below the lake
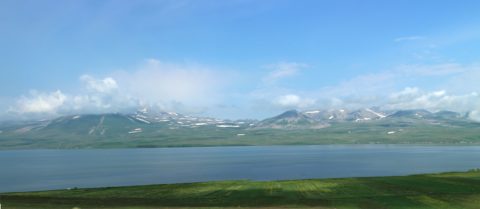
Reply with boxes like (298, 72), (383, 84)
(0, 171), (480, 209)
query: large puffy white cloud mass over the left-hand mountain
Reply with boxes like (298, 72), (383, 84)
(9, 59), (231, 117)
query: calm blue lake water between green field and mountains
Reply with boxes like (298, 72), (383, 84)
(0, 145), (480, 192)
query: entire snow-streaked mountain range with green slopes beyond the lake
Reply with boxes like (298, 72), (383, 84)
(0, 108), (480, 149)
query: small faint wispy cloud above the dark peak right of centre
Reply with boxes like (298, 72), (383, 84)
(263, 62), (307, 83)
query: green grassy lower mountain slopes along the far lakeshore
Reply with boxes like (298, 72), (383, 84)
(0, 117), (480, 150)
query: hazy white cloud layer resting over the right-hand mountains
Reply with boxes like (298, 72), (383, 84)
(249, 63), (480, 119)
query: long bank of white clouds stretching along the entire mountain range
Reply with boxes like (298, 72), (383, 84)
(4, 59), (480, 119)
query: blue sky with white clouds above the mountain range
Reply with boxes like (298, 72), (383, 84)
(0, 0), (480, 120)
